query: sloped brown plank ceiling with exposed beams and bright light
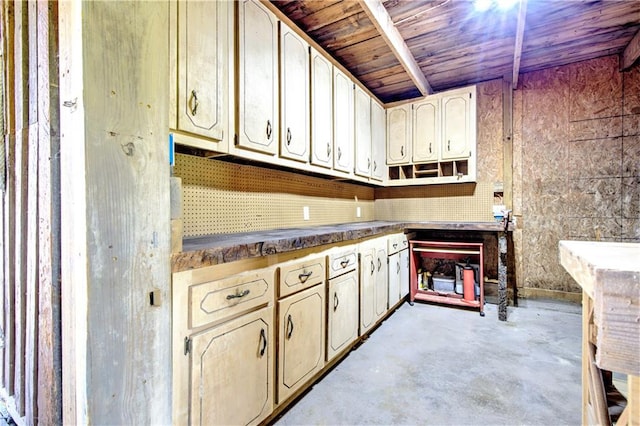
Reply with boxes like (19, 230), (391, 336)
(271, 0), (640, 103)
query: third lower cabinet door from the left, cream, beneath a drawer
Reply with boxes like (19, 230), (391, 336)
(327, 271), (360, 361)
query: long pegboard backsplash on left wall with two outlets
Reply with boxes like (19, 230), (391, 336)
(174, 154), (374, 237)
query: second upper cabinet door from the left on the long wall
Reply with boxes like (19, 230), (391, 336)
(237, 0), (278, 154)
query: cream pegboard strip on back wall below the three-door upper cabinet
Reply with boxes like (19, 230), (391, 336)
(375, 182), (494, 222)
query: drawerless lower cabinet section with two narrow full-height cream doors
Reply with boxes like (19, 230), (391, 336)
(358, 238), (389, 335)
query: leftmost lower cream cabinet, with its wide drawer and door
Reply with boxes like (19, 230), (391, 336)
(172, 264), (275, 425)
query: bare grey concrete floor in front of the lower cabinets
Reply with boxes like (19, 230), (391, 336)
(275, 300), (581, 426)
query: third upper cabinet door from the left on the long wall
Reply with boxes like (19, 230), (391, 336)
(280, 22), (310, 162)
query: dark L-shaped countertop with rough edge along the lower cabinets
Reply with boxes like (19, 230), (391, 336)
(171, 221), (504, 272)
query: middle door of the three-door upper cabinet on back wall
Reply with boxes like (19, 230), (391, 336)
(413, 98), (440, 163)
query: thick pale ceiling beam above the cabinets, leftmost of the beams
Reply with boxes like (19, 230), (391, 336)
(359, 0), (433, 95)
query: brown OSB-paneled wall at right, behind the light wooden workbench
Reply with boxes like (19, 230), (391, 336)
(514, 56), (640, 292)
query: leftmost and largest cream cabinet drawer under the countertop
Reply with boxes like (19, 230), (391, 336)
(189, 268), (275, 329)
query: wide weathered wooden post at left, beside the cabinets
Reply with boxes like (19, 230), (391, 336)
(59, 2), (171, 424)
